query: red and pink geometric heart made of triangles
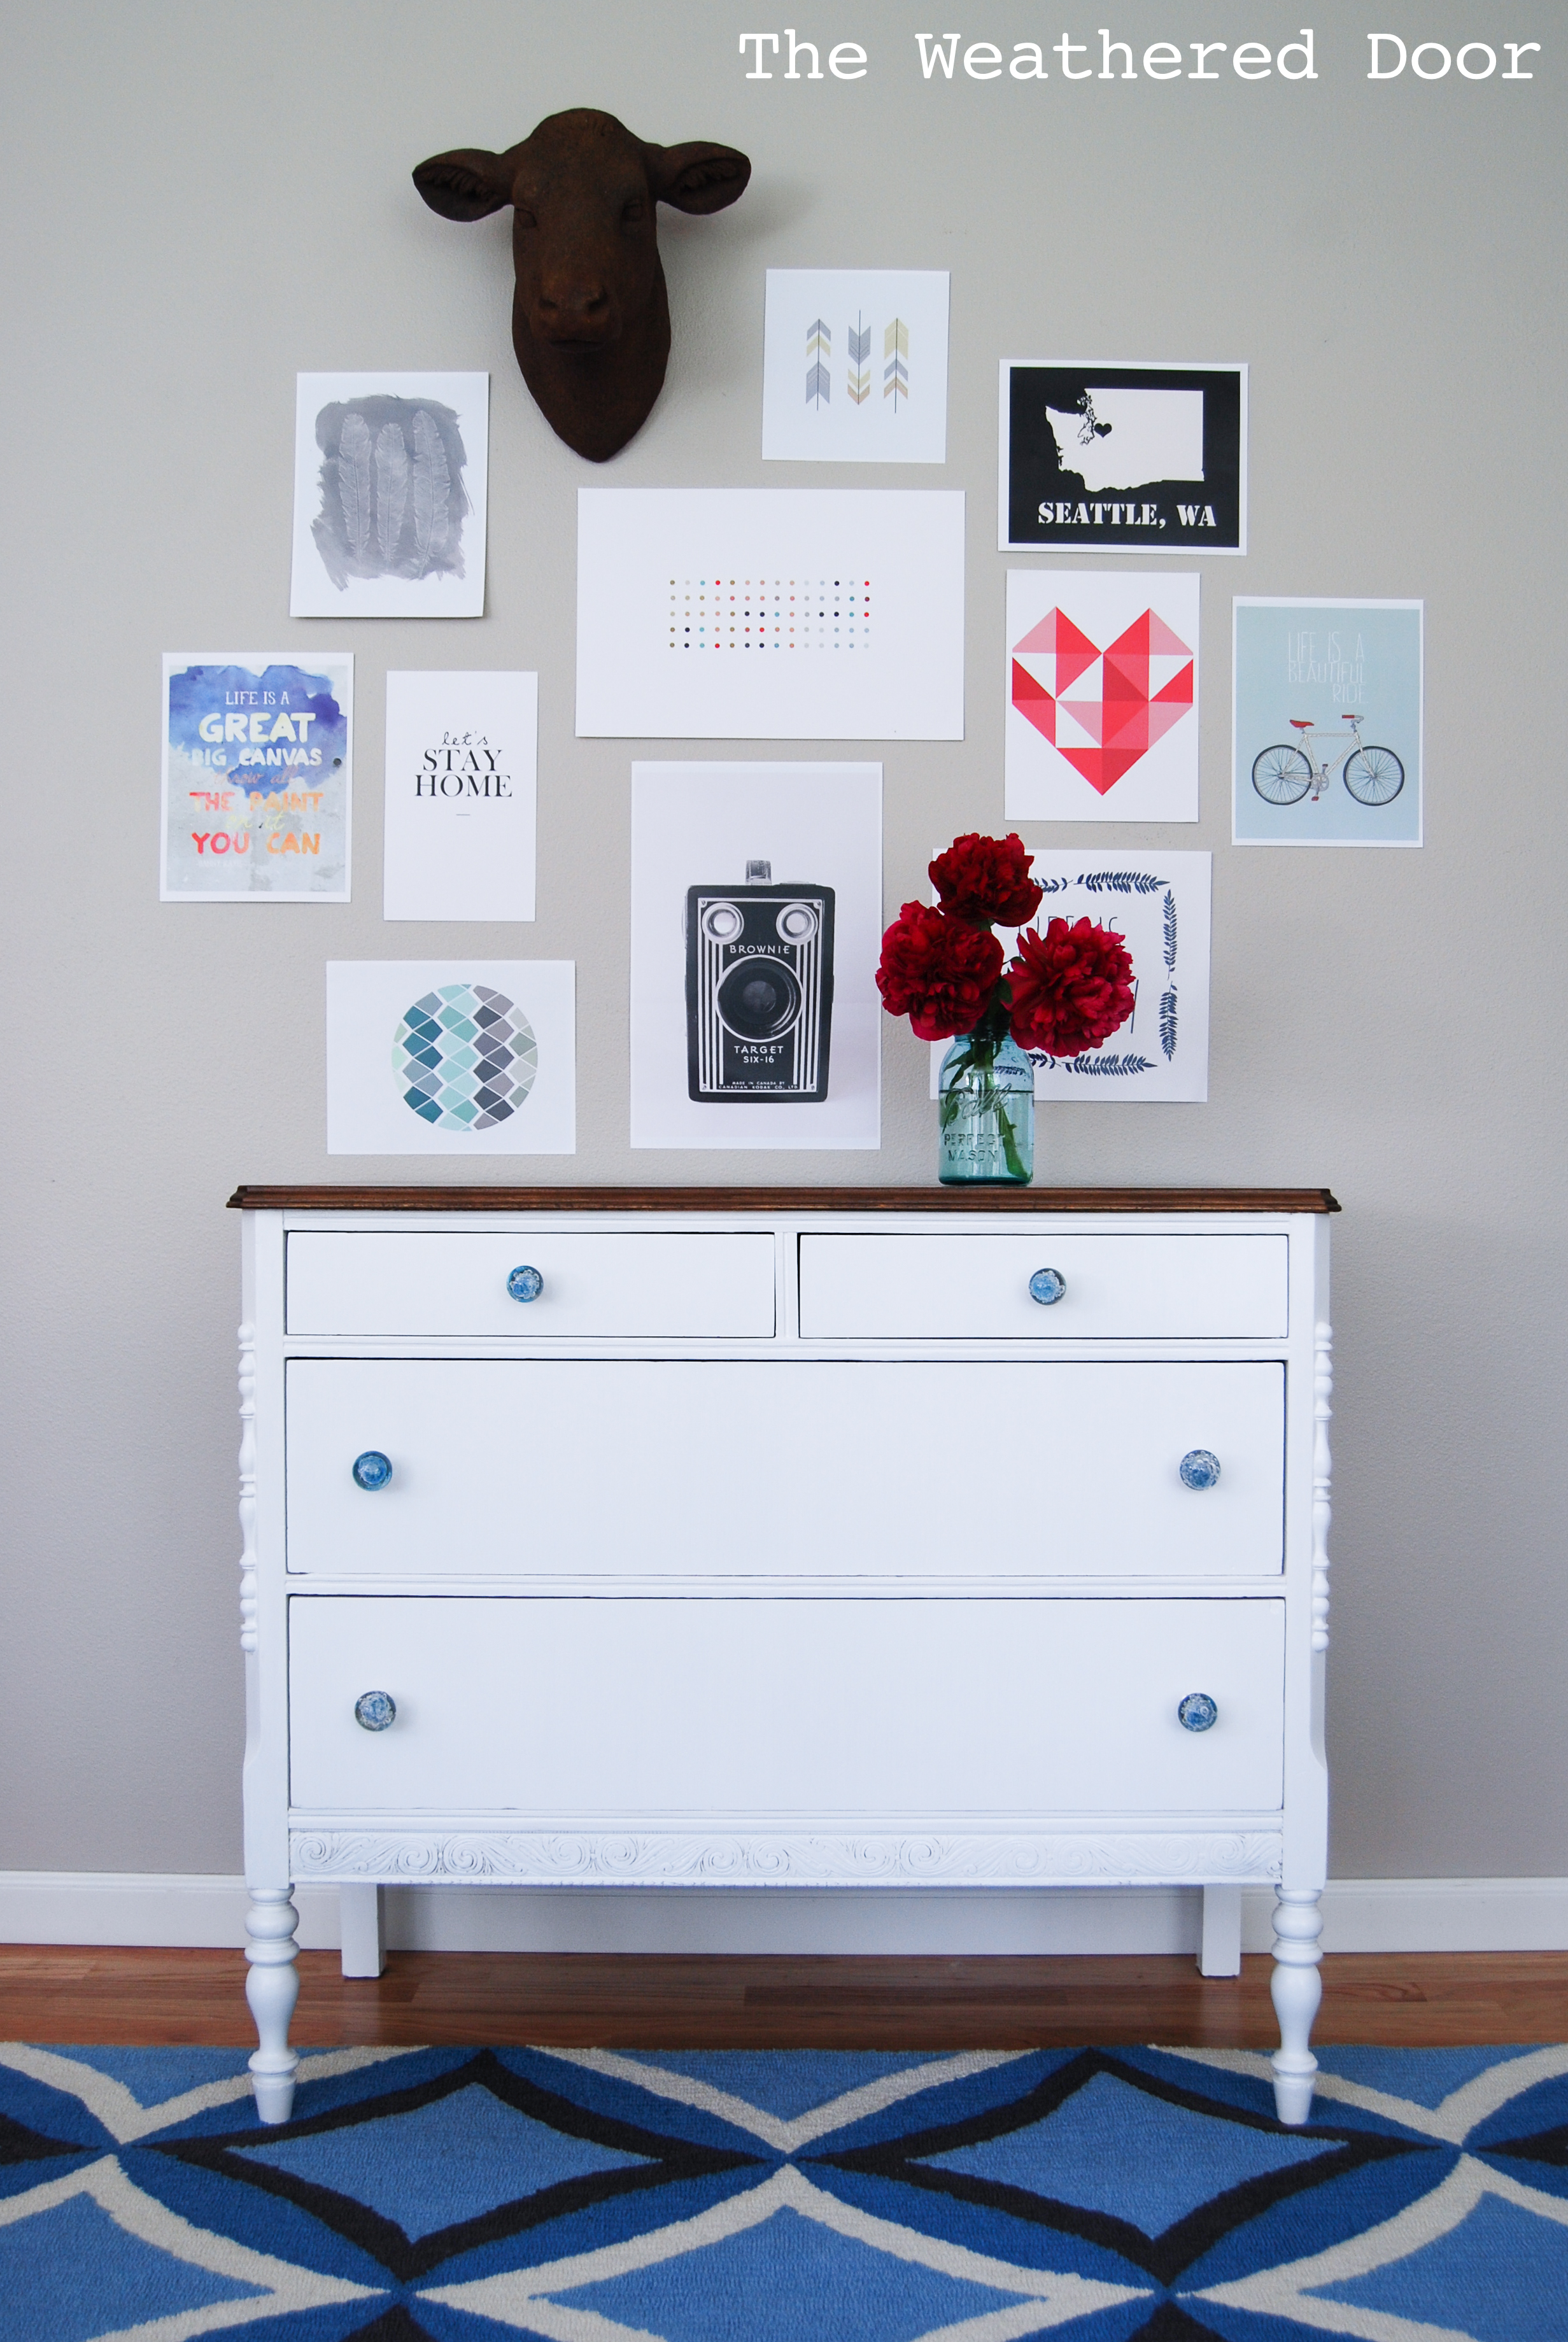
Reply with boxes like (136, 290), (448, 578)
(1012, 609), (1193, 796)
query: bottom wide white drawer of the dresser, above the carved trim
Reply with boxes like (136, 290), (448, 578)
(288, 1595), (1285, 1827)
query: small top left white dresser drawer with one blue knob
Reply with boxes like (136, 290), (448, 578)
(288, 1227), (773, 1342)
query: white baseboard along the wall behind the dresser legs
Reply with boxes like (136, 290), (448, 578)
(0, 1872), (1568, 1958)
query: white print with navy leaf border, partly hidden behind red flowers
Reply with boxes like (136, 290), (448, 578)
(931, 850), (1214, 1103)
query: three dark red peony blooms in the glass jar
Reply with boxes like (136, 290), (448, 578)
(877, 831), (1134, 1056)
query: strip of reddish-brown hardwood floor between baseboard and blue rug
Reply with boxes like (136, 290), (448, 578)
(0, 1944), (1568, 2049)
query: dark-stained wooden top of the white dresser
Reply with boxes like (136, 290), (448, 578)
(230, 1185), (1338, 1213)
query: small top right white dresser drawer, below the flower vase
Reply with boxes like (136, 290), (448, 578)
(799, 1229), (1289, 1342)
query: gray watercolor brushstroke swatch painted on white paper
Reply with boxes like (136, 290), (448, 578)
(309, 393), (469, 593)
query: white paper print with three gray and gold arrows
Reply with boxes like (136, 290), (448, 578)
(762, 269), (947, 463)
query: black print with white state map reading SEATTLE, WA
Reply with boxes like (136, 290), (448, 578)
(998, 358), (1247, 553)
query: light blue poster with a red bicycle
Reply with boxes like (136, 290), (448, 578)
(1231, 595), (1423, 845)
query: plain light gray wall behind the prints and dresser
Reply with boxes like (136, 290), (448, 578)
(0, 0), (1568, 1876)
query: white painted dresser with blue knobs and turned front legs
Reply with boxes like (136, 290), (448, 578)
(232, 1187), (1336, 2122)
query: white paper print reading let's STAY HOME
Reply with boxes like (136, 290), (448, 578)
(385, 670), (539, 918)
